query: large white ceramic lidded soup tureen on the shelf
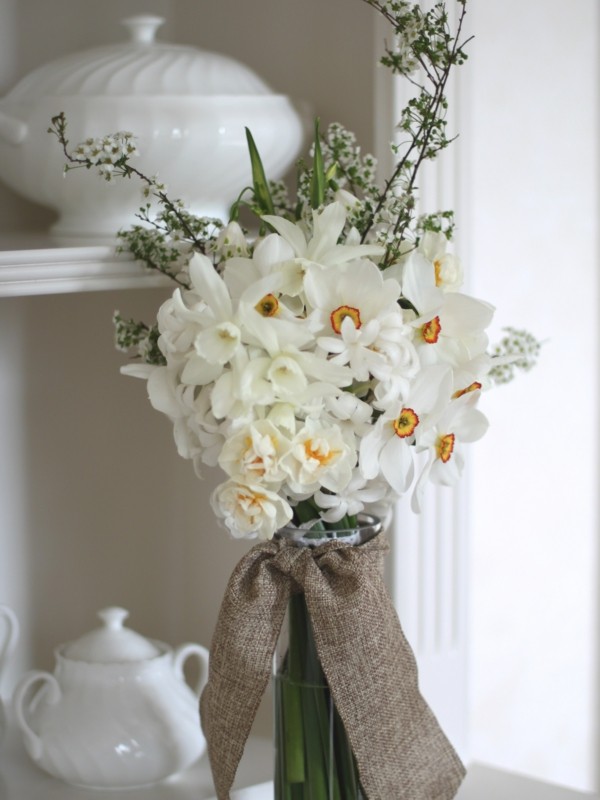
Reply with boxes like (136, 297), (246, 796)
(0, 16), (304, 240)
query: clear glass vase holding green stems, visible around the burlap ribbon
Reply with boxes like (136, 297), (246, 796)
(273, 515), (382, 800)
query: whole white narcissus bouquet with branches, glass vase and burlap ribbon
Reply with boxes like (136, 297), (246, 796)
(50, 0), (539, 800)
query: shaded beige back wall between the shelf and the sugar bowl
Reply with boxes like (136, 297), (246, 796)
(21, 290), (248, 668)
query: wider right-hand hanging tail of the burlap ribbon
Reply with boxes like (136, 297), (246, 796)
(304, 548), (465, 800)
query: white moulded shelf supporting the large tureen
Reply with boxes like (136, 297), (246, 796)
(0, 236), (171, 297)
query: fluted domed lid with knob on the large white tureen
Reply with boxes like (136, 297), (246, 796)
(9, 15), (272, 102)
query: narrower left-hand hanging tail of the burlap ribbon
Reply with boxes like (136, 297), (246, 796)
(200, 543), (289, 800)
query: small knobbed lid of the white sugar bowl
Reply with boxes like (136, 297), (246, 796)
(63, 606), (161, 663)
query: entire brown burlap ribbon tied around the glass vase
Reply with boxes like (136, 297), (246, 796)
(201, 535), (465, 800)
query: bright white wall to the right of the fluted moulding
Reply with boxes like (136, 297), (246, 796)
(459, 0), (600, 790)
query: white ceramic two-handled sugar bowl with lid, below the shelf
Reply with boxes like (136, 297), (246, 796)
(13, 608), (208, 789)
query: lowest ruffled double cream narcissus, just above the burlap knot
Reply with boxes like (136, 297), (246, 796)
(210, 480), (292, 539)
